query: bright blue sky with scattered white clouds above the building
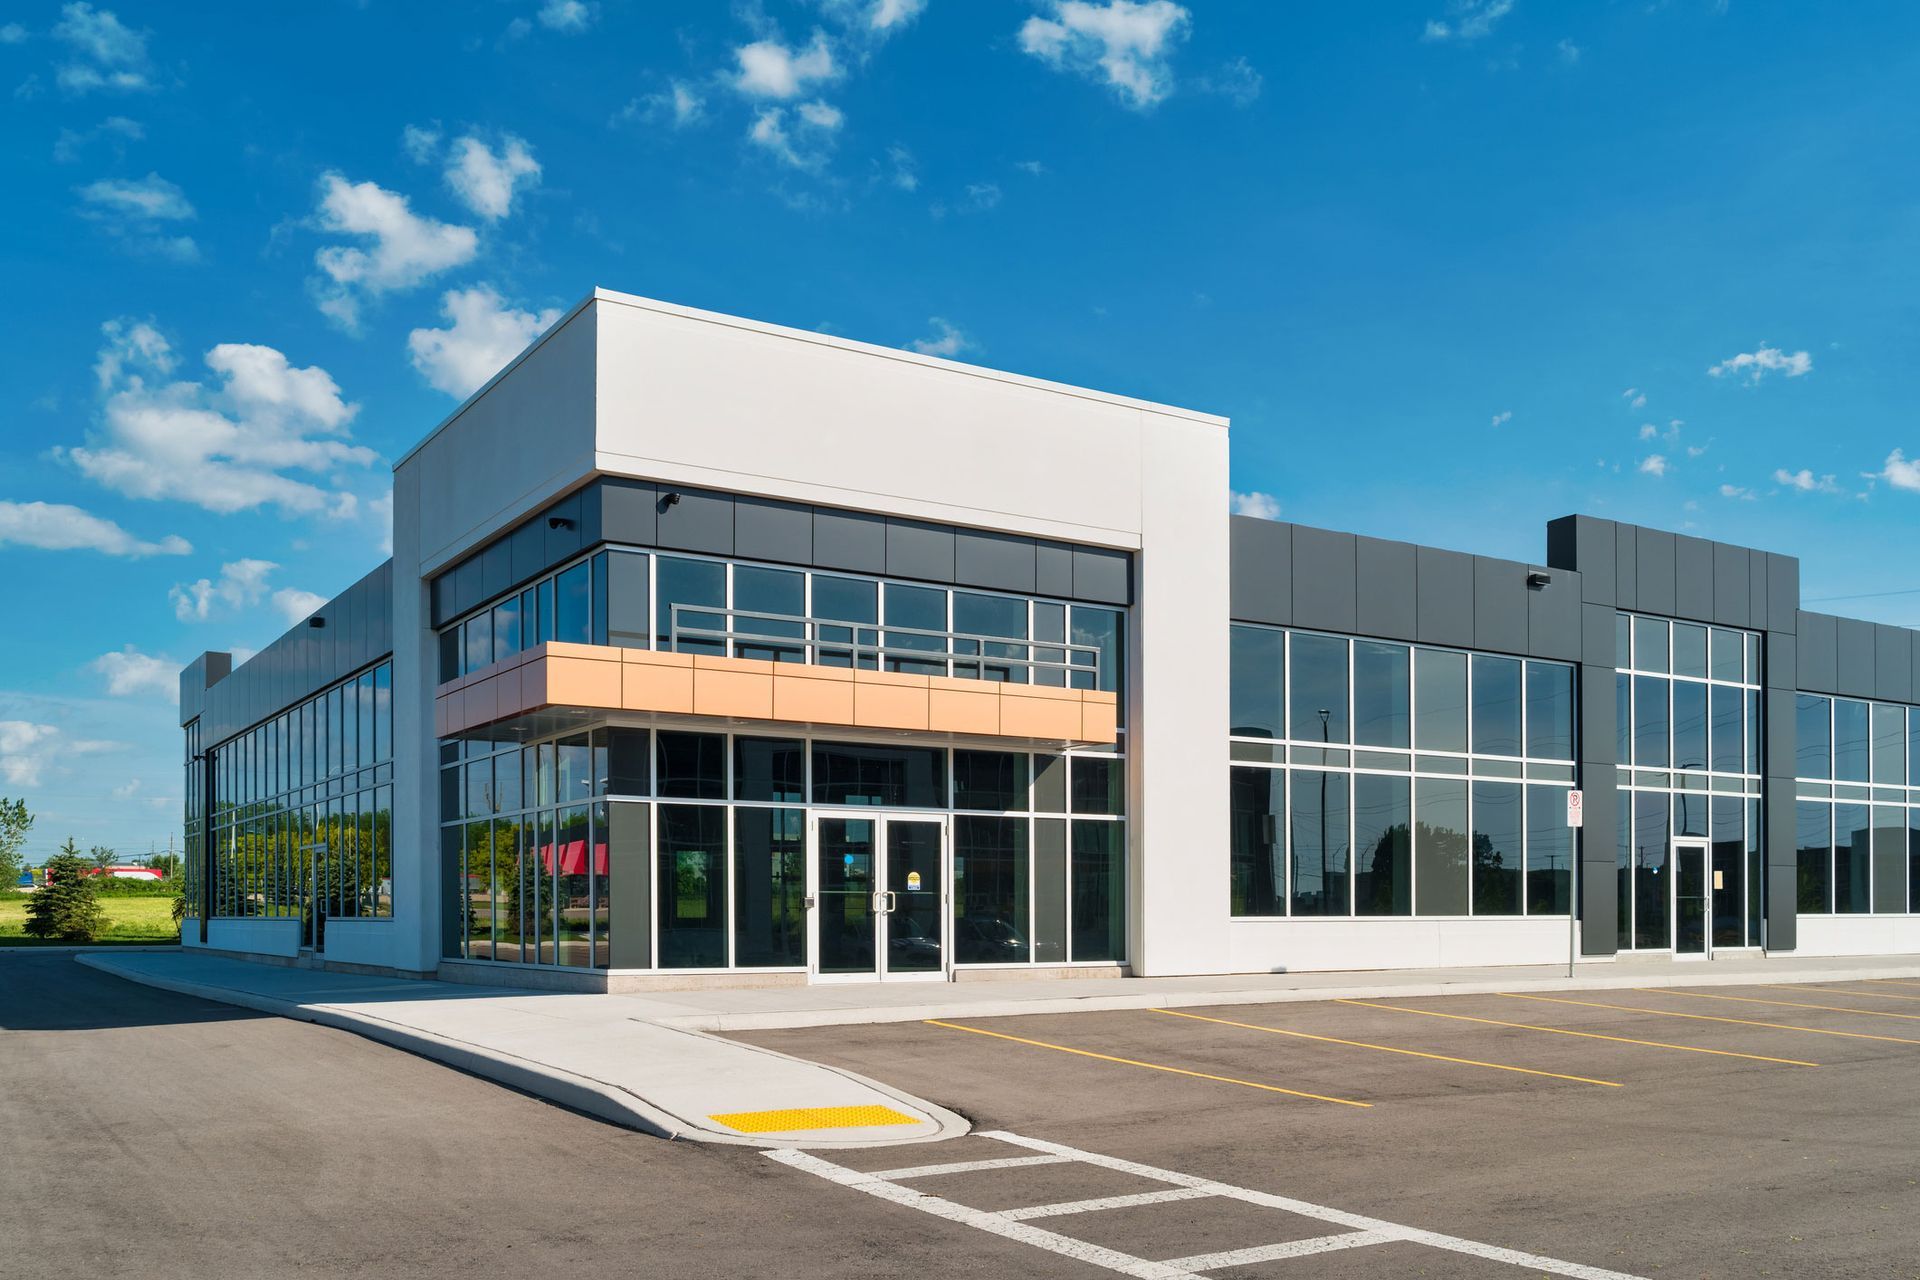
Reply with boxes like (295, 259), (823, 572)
(0, 0), (1920, 856)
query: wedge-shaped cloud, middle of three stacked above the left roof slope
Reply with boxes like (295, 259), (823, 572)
(313, 173), (480, 330)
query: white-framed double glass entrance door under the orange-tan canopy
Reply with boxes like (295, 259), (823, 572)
(812, 814), (948, 979)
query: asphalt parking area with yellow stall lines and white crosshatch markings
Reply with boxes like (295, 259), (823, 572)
(737, 981), (1920, 1280)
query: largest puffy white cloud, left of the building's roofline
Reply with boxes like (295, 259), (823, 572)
(56, 320), (374, 516)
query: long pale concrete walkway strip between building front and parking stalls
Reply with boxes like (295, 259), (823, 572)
(649, 963), (1920, 1034)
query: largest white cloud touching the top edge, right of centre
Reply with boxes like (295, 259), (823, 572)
(1020, 0), (1190, 111)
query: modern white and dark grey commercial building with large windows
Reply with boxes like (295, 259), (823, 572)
(180, 292), (1920, 988)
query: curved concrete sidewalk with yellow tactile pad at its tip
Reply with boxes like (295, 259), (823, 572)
(75, 950), (968, 1148)
